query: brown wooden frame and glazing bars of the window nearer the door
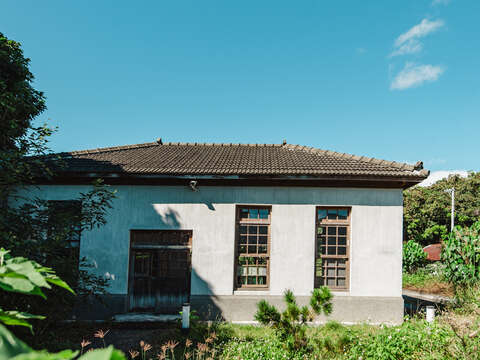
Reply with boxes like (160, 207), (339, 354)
(234, 205), (272, 290)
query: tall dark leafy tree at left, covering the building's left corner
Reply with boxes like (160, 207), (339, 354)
(0, 33), (114, 340)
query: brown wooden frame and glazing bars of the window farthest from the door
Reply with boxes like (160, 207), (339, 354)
(314, 206), (352, 291)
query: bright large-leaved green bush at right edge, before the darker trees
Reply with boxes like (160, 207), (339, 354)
(442, 221), (480, 286)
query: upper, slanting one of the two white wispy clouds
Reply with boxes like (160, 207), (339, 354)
(390, 19), (445, 56)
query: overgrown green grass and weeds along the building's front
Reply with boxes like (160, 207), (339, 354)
(23, 287), (480, 360)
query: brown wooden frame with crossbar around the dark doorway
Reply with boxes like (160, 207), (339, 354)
(125, 229), (193, 312)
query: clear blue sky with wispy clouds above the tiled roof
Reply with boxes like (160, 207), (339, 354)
(0, 0), (480, 171)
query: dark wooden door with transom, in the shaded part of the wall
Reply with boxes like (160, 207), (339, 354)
(129, 230), (192, 314)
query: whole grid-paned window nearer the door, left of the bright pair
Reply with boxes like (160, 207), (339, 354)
(236, 206), (271, 288)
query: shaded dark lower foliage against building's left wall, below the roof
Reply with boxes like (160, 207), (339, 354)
(0, 182), (114, 340)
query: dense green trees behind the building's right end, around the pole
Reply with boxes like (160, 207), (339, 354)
(404, 172), (480, 246)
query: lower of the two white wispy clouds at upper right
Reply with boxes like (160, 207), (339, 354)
(390, 62), (445, 90)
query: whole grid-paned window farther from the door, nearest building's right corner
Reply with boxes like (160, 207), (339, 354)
(315, 207), (350, 290)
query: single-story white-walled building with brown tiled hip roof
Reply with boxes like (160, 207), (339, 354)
(21, 139), (428, 323)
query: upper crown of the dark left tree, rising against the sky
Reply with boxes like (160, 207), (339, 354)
(0, 33), (52, 202)
